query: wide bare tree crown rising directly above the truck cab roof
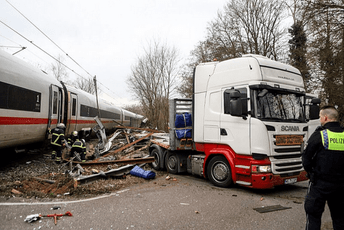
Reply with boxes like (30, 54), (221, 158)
(207, 0), (286, 60)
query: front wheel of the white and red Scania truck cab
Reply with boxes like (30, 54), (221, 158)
(207, 156), (233, 187)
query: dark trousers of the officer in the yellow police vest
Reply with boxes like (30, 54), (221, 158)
(305, 180), (344, 230)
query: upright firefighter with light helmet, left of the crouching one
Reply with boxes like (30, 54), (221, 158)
(49, 123), (66, 164)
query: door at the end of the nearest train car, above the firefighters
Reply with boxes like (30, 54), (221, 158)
(48, 85), (62, 127)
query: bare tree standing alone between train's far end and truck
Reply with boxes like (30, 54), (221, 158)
(127, 41), (178, 131)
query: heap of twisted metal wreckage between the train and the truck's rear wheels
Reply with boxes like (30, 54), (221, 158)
(63, 117), (158, 186)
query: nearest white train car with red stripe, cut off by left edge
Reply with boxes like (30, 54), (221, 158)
(0, 50), (63, 148)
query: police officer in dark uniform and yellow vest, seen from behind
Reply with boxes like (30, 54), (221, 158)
(302, 106), (344, 230)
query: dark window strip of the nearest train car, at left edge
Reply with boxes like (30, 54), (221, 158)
(0, 82), (41, 112)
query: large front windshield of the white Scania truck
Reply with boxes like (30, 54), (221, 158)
(256, 89), (305, 122)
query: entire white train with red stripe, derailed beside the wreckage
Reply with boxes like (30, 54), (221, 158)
(0, 50), (144, 149)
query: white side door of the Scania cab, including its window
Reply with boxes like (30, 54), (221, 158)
(220, 87), (251, 155)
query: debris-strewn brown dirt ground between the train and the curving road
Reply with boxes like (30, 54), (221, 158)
(0, 137), (167, 202)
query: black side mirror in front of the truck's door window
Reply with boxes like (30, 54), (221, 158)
(224, 89), (243, 117)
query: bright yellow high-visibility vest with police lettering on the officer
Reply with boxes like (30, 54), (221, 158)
(320, 129), (344, 151)
